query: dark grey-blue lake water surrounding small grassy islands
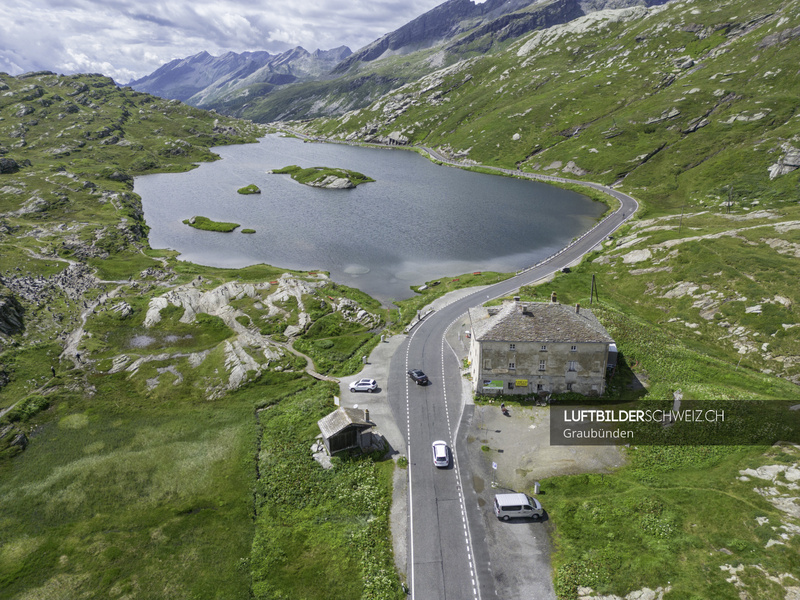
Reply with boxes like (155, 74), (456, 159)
(135, 135), (605, 301)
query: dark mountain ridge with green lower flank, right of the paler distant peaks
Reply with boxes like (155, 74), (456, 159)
(217, 0), (665, 122)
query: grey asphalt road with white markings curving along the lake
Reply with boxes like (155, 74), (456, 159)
(387, 158), (638, 600)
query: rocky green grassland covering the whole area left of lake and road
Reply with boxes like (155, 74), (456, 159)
(0, 73), (400, 599)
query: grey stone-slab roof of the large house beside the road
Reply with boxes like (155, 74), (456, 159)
(469, 302), (614, 343)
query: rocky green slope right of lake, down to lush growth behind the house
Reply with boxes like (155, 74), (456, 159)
(290, 0), (800, 386)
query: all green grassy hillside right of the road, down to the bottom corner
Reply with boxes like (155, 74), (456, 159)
(288, 0), (800, 600)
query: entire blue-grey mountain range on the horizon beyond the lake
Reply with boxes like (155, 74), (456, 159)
(129, 0), (666, 121)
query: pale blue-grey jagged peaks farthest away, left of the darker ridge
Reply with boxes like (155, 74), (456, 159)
(129, 46), (351, 107)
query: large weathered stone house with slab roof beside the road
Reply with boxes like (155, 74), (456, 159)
(469, 293), (614, 396)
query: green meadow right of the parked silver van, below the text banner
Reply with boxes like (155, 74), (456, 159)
(542, 445), (800, 600)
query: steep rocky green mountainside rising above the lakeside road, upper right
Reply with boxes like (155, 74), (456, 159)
(310, 0), (800, 209)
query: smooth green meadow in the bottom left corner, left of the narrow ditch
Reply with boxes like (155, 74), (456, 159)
(0, 382), (255, 599)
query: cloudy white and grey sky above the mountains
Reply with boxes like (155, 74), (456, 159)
(0, 0), (444, 84)
